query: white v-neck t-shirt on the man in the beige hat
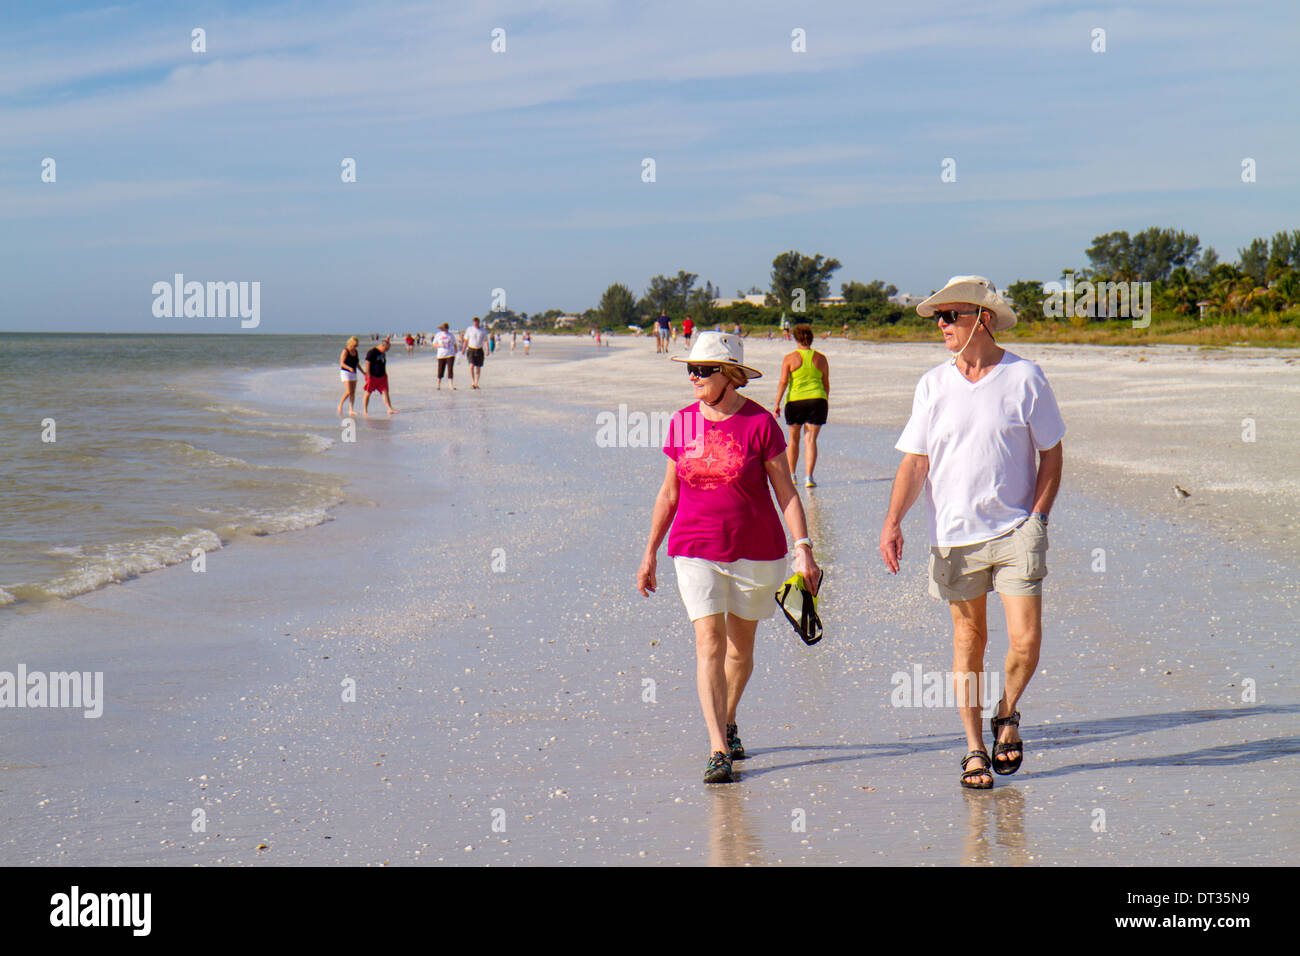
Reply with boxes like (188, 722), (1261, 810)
(894, 352), (1065, 548)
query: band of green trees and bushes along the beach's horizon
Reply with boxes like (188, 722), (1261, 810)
(493, 226), (1300, 346)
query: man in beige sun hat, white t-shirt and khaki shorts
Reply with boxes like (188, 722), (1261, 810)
(880, 276), (1065, 790)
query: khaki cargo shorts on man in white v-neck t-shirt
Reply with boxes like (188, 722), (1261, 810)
(930, 515), (1048, 601)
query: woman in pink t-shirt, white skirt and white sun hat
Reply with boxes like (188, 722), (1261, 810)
(637, 332), (820, 783)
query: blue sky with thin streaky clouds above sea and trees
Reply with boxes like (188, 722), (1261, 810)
(0, 0), (1300, 333)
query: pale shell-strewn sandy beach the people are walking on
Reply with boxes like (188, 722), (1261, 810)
(0, 338), (1300, 865)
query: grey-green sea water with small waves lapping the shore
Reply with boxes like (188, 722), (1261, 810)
(0, 333), (368, 613)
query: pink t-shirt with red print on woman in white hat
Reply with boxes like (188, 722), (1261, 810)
(663, 399), (785, 562)
